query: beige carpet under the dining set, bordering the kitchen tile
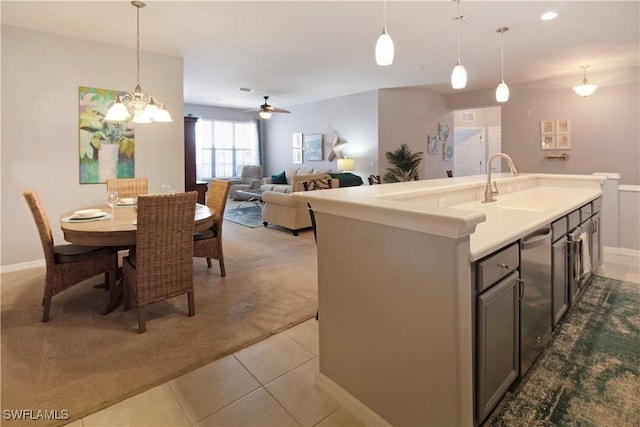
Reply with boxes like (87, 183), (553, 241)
(0, 222), (317, 426)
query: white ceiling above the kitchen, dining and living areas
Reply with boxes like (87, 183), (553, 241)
(1, 0), (640, 108)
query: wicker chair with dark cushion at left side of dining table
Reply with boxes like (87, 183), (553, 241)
(23, 190), (118, 322)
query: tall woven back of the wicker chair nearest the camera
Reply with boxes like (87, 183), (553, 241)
(136, 191), (198, 305)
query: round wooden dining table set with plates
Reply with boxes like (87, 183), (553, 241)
(59, 203), (215, 314)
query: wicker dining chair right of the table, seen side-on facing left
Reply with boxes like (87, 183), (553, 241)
(193, 179), (231, 277)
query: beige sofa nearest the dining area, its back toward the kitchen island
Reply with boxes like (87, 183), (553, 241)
(261, 173), (340, 236)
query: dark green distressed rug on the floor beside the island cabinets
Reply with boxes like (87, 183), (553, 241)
(485, 276), (640, 427)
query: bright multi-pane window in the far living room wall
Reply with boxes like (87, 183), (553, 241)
(196, 119), (260, 181)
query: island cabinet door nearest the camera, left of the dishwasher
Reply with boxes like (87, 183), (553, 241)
(476, 271), (520, 422)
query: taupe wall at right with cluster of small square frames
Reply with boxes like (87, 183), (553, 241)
(447, 81), (640, 185)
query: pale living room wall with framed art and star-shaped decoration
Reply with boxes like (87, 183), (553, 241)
(263, 91), (378, 179)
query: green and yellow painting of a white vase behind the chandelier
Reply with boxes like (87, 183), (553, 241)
(79, 86), (136, 184)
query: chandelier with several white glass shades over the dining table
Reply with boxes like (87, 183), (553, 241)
(104, 1), (173, 123)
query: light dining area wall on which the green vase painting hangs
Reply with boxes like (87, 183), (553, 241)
(0, 26), (184, 266)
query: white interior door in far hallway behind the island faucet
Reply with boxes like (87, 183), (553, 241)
(453, 127), (485, 176)
